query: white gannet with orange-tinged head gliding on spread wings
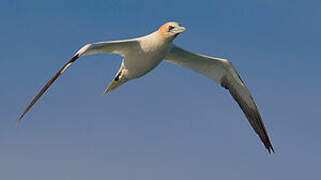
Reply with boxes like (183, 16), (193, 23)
(17, 22), (274, 153)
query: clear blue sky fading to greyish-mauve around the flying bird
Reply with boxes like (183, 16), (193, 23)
(0, 0), (321, 180)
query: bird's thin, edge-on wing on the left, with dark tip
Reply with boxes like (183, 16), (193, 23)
(17, 39), (138, 123)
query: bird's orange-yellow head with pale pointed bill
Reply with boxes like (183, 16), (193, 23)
(157, 22), (186, 38)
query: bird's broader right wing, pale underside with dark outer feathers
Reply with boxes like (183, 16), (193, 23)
(165, 45), (274, 152)
